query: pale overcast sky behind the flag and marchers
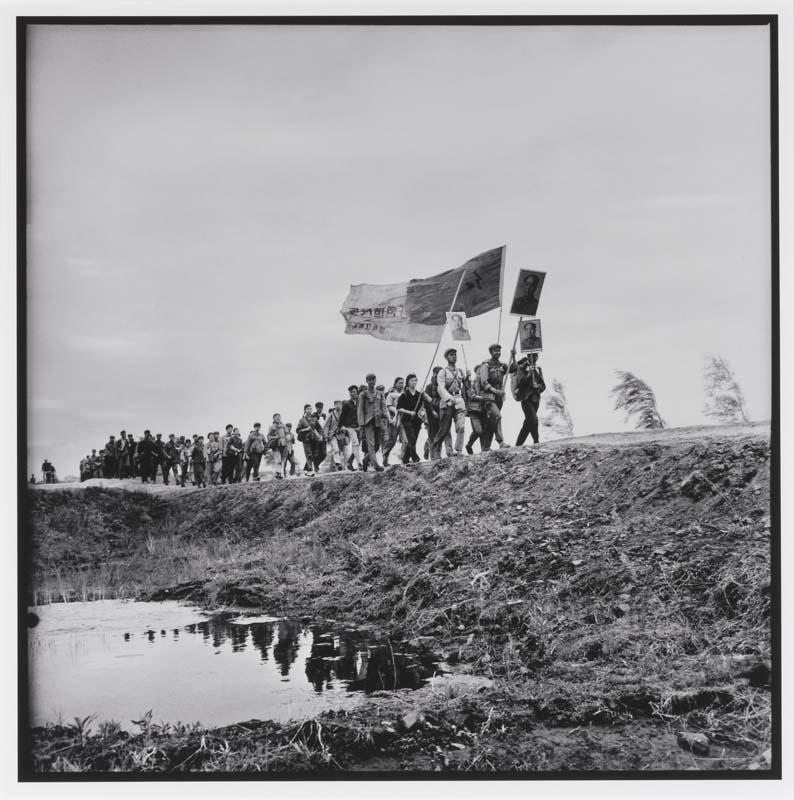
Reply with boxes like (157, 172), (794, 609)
(28, 26), (771, 476)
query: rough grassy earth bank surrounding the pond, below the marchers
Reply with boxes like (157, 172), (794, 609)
(23, 426), (771, 771)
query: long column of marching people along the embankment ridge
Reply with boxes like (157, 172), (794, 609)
(80, 344), (546, 487)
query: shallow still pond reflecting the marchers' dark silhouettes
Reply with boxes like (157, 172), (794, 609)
(28, 600), (437, 731)
